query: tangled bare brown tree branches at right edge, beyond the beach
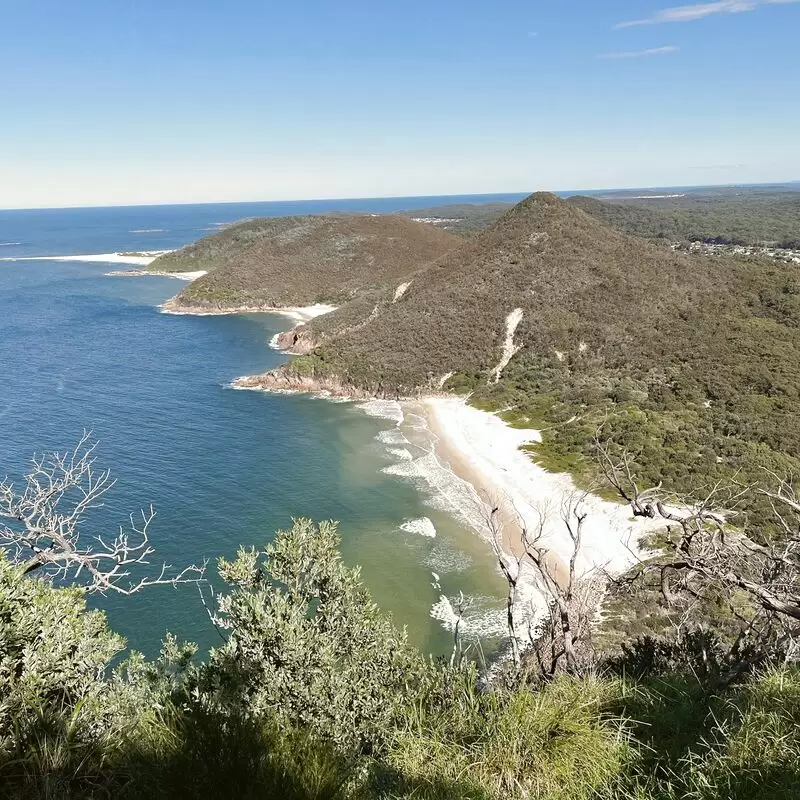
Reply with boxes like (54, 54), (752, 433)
(596, 440), (800, 668)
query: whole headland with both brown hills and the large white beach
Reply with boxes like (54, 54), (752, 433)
(109, 186), (800, 636)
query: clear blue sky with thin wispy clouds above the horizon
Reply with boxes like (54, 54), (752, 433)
(0, 0), (800, 208)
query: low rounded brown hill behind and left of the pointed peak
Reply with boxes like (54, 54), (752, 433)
(150, 215), (460, 308)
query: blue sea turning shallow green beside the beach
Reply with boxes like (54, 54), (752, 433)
(0, 200), (503, 654)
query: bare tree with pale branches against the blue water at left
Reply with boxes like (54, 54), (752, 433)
(0, 433), (206, 595)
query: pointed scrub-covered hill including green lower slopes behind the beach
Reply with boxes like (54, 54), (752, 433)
(286, 194), (800, 496)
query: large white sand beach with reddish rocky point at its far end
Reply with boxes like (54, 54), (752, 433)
(231, 369), (663, 576)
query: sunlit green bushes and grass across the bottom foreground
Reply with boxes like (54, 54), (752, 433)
(0, 520), (800, 800)
